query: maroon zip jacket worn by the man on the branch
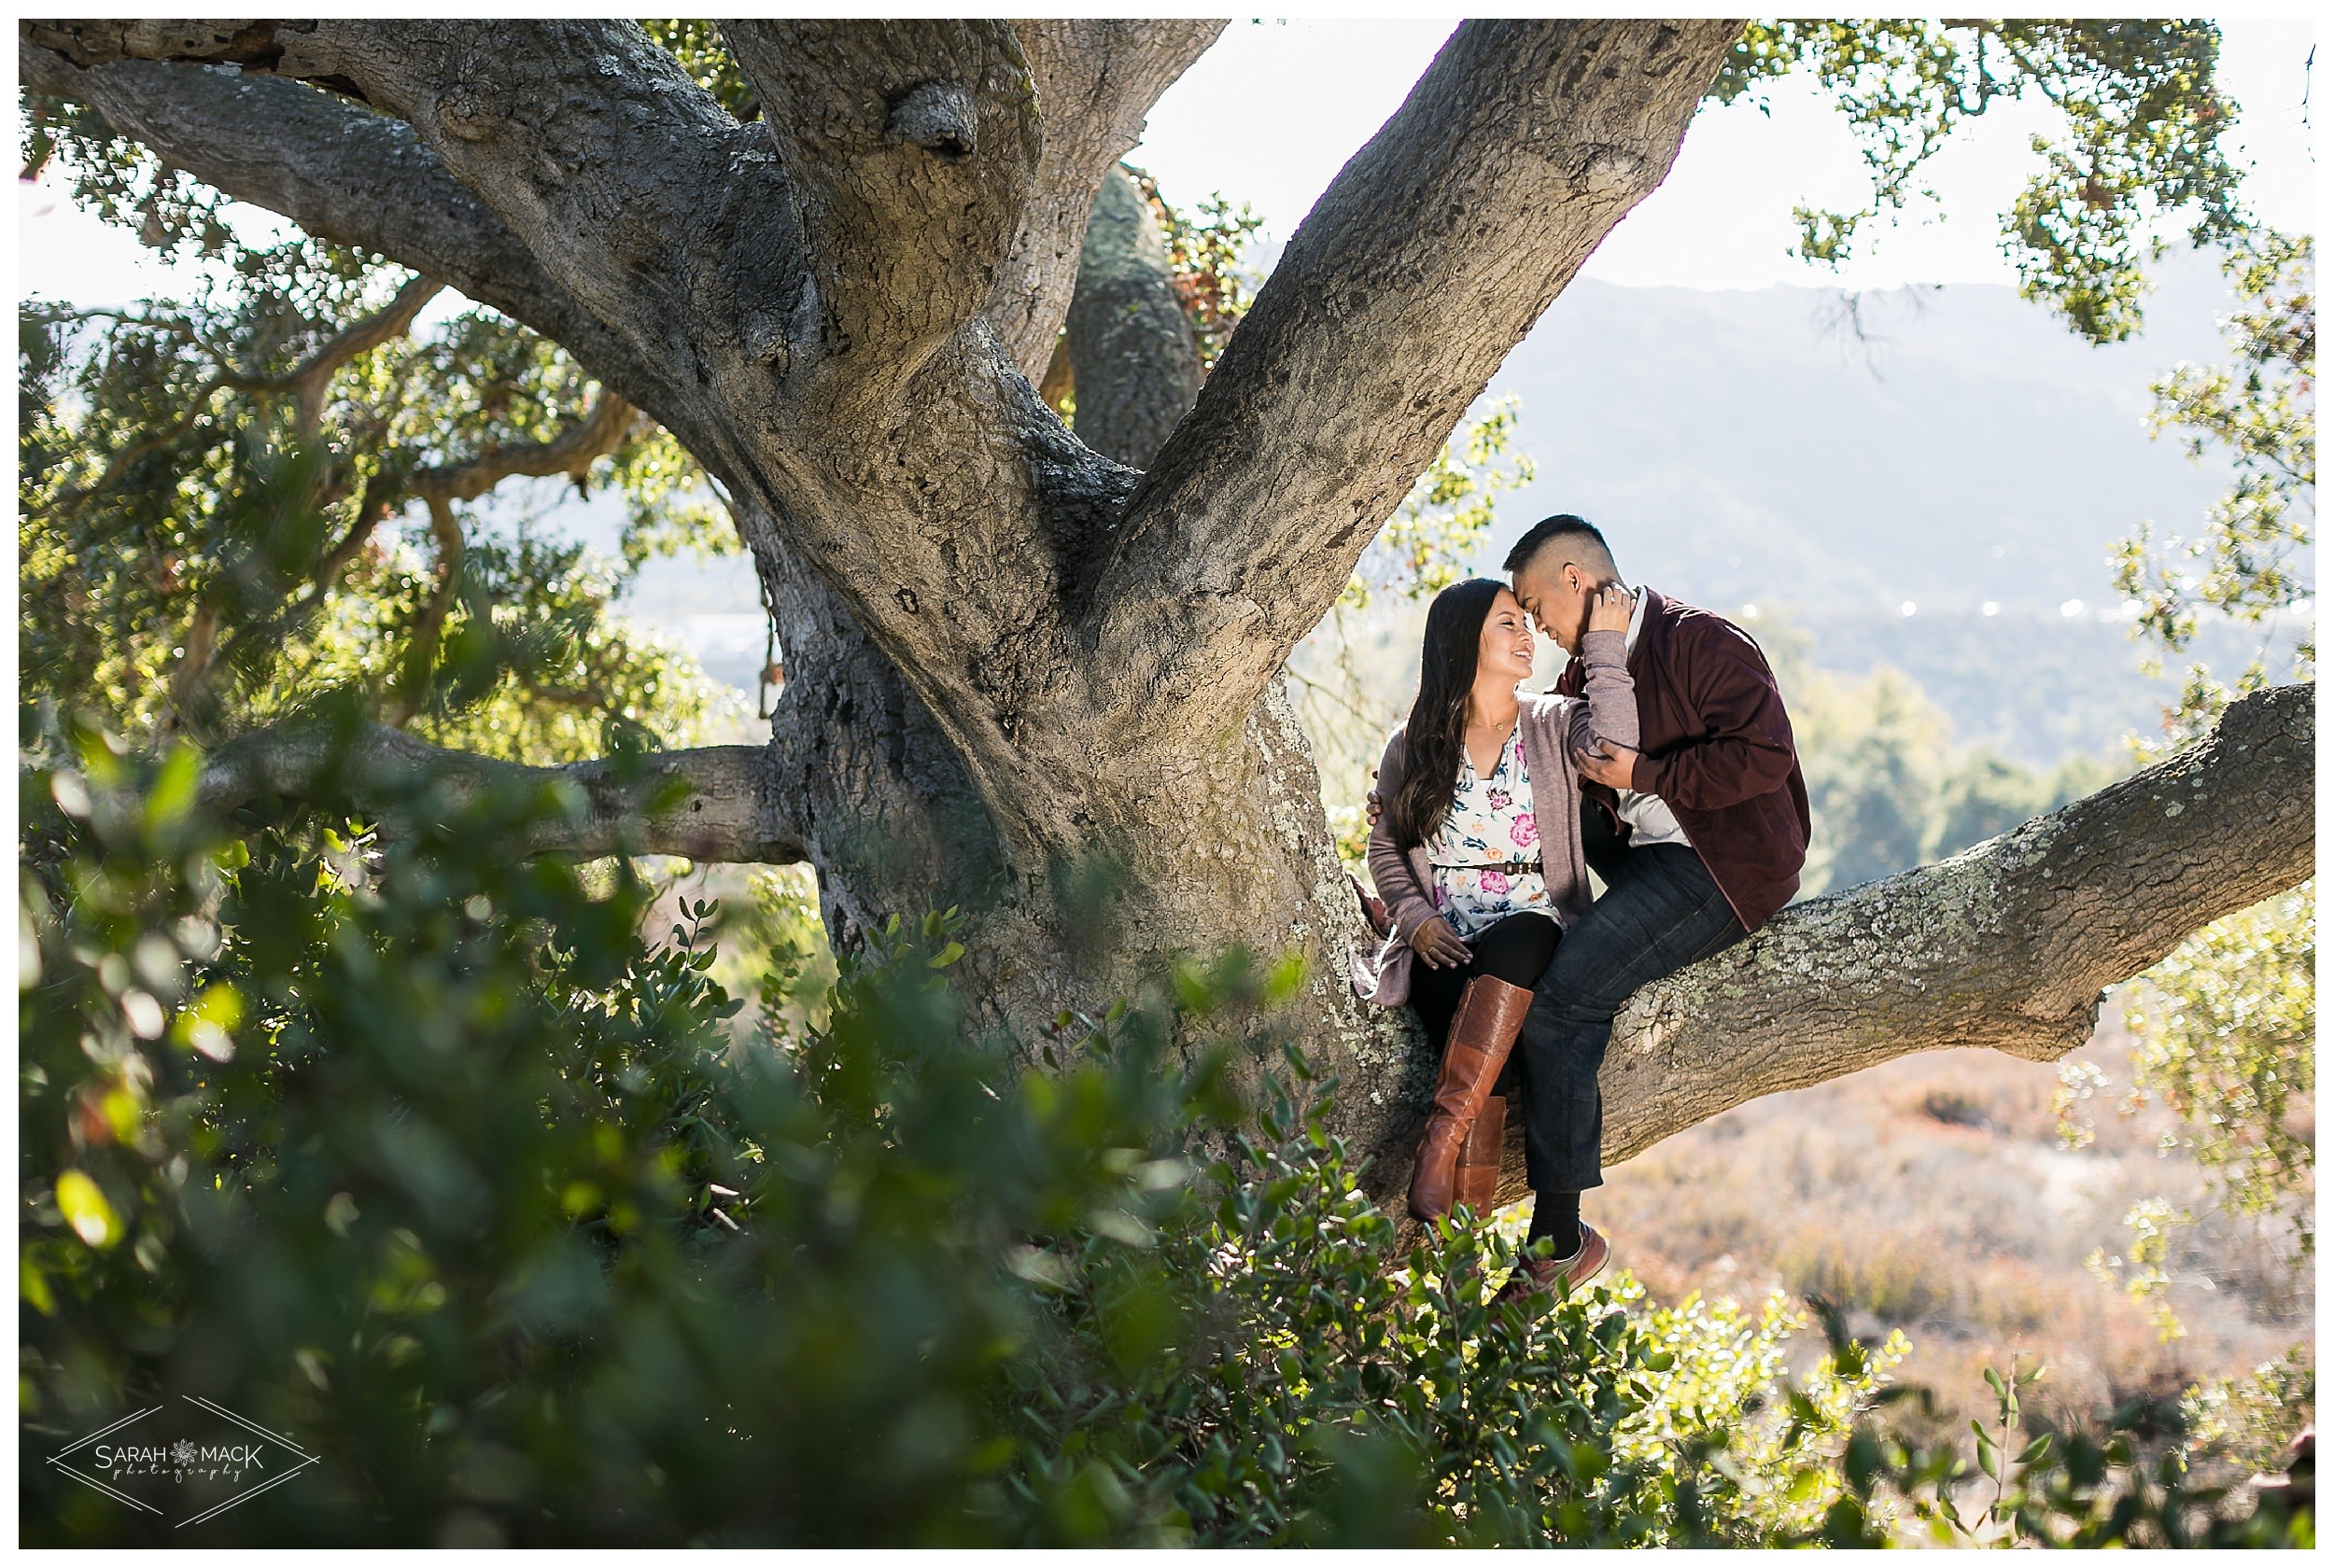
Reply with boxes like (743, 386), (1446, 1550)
(1557, 588), (1809, 931)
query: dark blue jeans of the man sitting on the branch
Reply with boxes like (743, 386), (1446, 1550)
(1515, 801), (1746, 1193)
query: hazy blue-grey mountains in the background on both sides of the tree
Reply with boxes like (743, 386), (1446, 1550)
(598, 257), (2290, 765)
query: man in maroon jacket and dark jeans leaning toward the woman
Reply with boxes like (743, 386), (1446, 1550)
(1419, 513), (1809, 1302)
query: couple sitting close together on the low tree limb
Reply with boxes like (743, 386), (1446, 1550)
(1357, 516), (1809, 1302)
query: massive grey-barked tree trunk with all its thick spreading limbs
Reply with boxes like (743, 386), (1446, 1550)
(19, 19), (2311, 1190)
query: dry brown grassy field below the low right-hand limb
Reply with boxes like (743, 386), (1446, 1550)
(1582, 1015), (2315, 1456)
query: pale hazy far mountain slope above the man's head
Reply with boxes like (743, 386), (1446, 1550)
(1492, 266), (2220, 619)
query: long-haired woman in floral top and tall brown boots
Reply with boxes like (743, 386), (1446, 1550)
(1357, 577), (1637, 1283)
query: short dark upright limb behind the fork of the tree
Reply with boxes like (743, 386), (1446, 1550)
(1069, 166), (1200, 469)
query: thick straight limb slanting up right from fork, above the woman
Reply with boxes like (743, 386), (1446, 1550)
(1086, 19), (1741, 747)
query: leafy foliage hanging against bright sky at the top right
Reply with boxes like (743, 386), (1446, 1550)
(1711, 19), (2245, 343)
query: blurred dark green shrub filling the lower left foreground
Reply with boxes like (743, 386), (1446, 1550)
(19, 731), (2315, 1545)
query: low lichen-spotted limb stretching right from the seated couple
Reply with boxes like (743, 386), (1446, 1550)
(1475, 686), (2318, 1197)
